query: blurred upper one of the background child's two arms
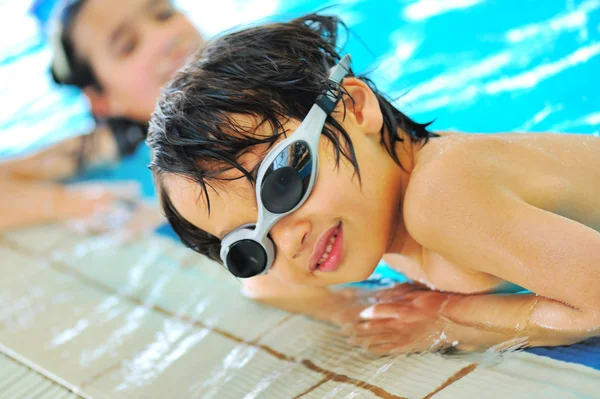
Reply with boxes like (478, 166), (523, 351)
(0, 126), (118, 180)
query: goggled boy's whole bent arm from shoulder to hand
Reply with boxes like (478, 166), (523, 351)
(345, 161), (600, 349)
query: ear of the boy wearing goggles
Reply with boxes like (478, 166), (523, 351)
(342, 78), (383, 134)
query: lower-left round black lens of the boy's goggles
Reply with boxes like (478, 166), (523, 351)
(227, 240), (267, 278)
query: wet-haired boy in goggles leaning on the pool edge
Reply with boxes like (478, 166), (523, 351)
(148, 15), (600, 353)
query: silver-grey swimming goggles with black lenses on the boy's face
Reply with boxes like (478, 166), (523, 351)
(220, 55), (351, 278)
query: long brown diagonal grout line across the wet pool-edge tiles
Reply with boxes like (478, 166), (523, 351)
(0, 236), (407, 399)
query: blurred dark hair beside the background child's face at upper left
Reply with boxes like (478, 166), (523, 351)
(50, 0), (102, 90)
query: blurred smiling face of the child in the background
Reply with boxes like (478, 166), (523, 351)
(72, 0), (203, 121)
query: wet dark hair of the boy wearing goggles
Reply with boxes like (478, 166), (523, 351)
(147, 14), (435, 263)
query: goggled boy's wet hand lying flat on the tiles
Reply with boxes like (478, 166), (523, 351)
(335, 284), (456, 354)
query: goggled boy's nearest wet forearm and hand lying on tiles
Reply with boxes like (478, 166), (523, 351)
(344, 291), (600, 354)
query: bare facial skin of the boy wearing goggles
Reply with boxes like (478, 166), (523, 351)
(164, 80), (412, 286)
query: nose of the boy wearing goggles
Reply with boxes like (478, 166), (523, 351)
(271, 216), (312, 260)
